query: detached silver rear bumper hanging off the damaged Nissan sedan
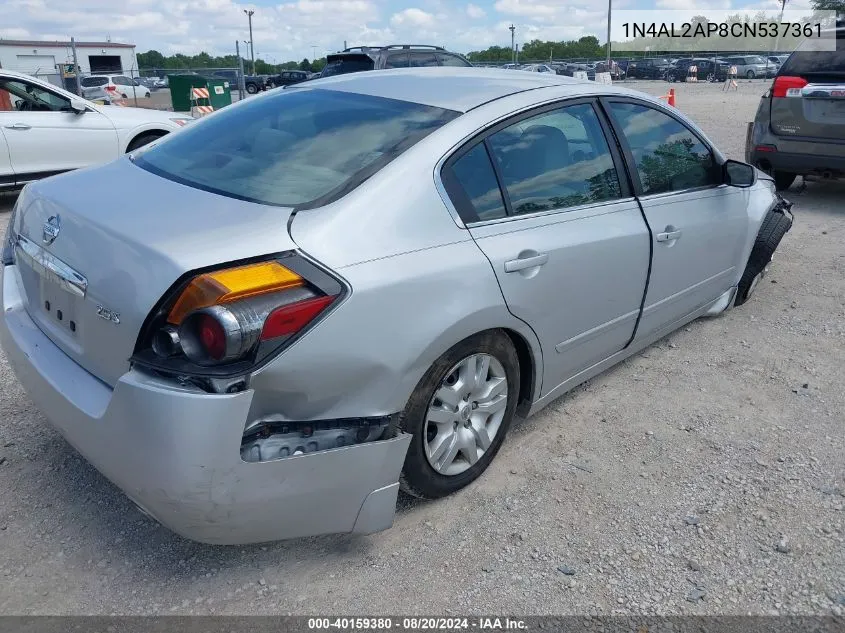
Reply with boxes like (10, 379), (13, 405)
(0, 266), (410, 544)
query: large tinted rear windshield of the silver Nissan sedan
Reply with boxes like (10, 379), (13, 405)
(135, 88), (459, 208)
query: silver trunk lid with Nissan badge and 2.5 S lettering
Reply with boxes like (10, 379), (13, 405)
(15, 158), (295, 386)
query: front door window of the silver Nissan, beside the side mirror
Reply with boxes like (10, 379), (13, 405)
(610, 103), (721, 194)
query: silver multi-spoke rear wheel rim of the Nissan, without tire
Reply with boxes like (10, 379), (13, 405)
(423, 354), (508, 476)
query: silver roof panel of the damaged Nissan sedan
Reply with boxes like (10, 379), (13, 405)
(298, 66), (642, 112)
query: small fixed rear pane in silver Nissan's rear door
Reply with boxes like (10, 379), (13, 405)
(443, 142), (507, 223)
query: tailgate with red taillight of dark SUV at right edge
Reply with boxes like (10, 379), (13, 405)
(770, 35), (845, 143)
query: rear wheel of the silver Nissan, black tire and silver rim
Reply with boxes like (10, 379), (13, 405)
(398, 330), (520, 499)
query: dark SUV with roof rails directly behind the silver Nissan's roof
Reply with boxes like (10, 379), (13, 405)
(321, 44), (472, 77)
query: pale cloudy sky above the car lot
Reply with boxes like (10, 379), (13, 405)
(0, 0), (809, 63)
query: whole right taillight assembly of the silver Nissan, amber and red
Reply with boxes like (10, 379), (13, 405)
(133, 255), (343, 376)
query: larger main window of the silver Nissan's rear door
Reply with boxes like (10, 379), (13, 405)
(489, 104), (621, 215)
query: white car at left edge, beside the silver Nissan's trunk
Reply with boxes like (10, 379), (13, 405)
(0, 69), (193, 190)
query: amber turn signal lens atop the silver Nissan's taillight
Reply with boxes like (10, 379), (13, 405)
(167, 261), (305, 325)
